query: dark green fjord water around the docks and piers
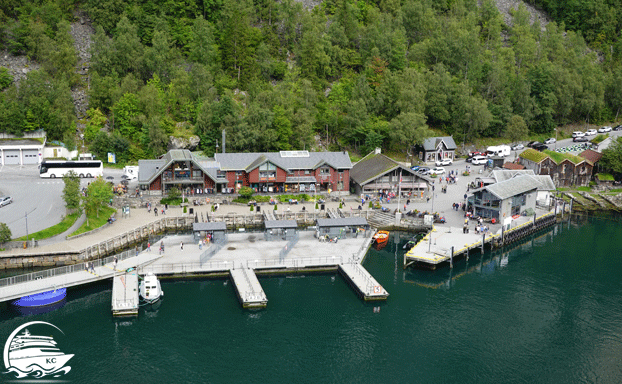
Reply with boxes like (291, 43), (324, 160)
(0, 218), (622, 383)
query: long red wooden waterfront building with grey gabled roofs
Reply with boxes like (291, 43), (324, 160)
(138, 150), (352, 194)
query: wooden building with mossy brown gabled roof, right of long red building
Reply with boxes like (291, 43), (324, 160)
(350, 148), (430, 197)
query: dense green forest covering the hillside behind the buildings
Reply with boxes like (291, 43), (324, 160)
(0, 0), (622, 161)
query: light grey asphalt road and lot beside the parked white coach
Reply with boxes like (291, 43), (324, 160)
(0, 165), (130, 238)
